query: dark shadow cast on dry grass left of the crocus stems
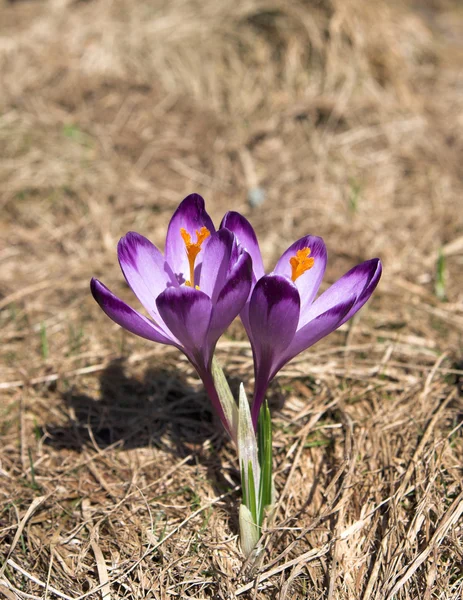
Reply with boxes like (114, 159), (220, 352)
(45, 359), (231, 457)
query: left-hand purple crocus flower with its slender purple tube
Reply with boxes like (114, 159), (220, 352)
(90, 194), (252, 434)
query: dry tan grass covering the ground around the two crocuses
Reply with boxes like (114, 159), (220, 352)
(0, 0), (463, 600)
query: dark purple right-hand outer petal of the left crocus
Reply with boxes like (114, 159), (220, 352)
(208, 245), (252, 347)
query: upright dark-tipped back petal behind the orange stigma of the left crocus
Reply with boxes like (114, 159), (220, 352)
(165, 194), (215, 284)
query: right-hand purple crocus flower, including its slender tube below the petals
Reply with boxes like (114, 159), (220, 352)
(221, 212), (382, 426)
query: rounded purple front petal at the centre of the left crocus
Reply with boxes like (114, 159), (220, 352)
(156, 286), (212, 370)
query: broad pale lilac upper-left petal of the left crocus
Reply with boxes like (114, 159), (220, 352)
(117, 232), (178, 320)
